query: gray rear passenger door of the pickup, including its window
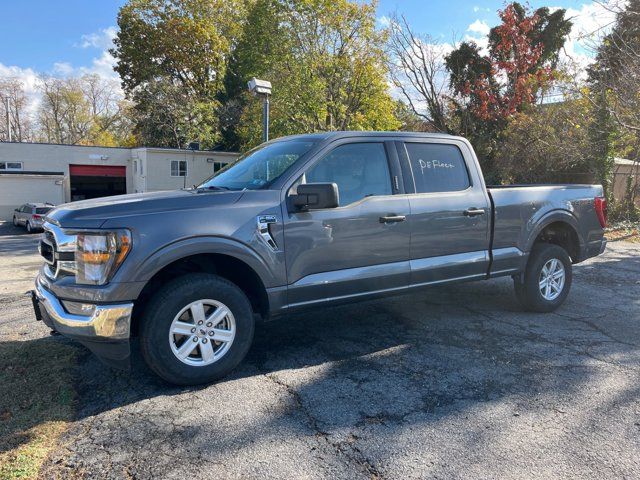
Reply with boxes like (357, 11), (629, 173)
(396, 139), (491, 285)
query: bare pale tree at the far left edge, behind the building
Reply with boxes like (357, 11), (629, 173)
(0, 77), (32, 142)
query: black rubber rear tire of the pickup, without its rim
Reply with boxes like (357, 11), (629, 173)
(513, 243), (572, 313)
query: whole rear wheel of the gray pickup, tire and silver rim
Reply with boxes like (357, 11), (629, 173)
(513, 243), (572, 312)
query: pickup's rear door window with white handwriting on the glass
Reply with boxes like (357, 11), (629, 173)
(405, 143), (471, 193)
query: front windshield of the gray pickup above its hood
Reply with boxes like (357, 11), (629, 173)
(198, 140), (315, 190)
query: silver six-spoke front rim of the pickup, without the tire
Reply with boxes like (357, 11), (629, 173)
(169, 299), (236, 367)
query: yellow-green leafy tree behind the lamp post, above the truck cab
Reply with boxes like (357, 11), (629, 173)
(233, 0), (399, 146)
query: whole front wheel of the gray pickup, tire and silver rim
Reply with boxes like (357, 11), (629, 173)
(140, 273), (254, 385)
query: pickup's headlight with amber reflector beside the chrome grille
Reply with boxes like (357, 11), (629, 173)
(76, 230), (131, 285)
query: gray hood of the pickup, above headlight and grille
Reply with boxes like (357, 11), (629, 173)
(46, 190), (243, 228)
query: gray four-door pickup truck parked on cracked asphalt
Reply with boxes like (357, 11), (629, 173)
(32, 132), (606, 385)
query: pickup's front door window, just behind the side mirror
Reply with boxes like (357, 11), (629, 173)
(304, 143), (392, 206)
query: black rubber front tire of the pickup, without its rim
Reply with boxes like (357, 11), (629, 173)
(140, 273), (254, 385)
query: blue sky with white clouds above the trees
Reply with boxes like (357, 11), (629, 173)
(0, 0), (605, 86)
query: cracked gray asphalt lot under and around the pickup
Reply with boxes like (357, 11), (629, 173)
(0, 222), (640, 479)
